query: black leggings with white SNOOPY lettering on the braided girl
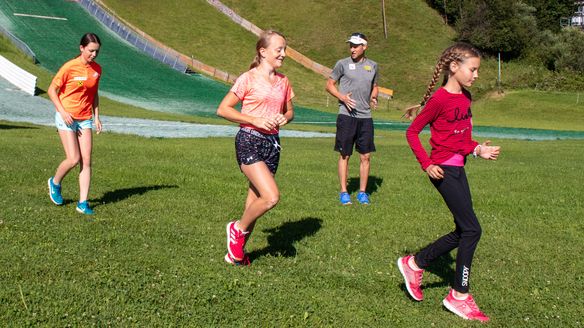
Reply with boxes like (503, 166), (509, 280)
(415, 166), (481, 293)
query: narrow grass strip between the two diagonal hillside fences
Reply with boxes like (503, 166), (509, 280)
(98, 0), (326, 107)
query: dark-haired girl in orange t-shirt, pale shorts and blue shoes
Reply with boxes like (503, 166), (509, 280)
(47, 33), (101, 214)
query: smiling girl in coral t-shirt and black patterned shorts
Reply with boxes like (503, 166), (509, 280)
(217, 30), (294, 265)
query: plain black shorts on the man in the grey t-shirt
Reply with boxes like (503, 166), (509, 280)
(335, 114), (375, 156)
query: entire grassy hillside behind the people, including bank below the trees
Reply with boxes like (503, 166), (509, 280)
(104, 0), (584, 130)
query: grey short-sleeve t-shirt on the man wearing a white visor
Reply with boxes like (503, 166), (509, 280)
(330, 57), (377, 118)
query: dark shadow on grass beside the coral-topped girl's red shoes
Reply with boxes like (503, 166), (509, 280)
(249, 218), (322, 262)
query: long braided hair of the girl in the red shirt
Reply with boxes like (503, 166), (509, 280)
(404, 42), (481, 120)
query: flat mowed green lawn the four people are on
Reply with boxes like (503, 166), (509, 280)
(0, 122), (584, 327)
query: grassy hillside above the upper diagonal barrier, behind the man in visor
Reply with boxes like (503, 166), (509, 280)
(223, 0), (454, 101)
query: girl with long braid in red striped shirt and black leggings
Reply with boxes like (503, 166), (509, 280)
(397, 43), (499, 321)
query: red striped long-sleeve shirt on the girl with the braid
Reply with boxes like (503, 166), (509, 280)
(406, 88), (478, 170)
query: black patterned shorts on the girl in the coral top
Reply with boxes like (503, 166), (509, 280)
(235, 128), (282, 174)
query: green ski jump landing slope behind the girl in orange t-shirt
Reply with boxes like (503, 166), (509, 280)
(0, 0), (235, 116)
